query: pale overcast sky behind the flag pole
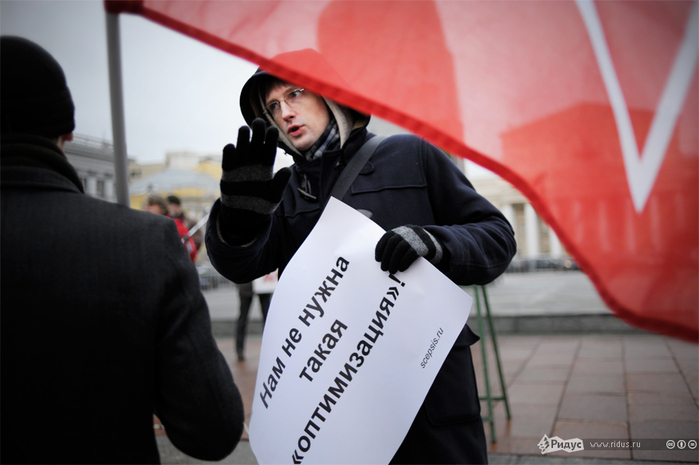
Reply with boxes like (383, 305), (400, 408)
(0, 0), (257, 162)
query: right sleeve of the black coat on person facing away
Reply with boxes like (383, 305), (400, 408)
(154, 222), (244, 461)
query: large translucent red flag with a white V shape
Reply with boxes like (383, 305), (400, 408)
(106, 0), (699, 342)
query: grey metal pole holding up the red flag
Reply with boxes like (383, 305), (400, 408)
(106, 13), (131, 207)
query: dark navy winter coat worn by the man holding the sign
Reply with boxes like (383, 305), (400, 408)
(206, 118), (516, 463)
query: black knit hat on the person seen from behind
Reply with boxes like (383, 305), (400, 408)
(0, 36), (75, 138)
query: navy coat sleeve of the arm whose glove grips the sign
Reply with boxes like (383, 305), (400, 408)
(422, 141), (517, 285)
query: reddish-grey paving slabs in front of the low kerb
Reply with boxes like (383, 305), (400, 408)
(159, 333), (699, 464)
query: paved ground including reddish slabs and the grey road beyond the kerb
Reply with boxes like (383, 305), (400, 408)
(158, 272), (699, 465)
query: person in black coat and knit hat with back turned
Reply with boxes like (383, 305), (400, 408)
(0, 36), (244, 463)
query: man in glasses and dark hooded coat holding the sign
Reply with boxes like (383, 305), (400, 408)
(206, 50), (516, 463)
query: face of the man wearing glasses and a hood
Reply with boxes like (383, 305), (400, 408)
(265, 83), (330, 152)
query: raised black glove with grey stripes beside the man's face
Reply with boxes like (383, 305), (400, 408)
(218, 118), (291, 245)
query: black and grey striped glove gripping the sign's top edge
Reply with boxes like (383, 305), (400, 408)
(375, 224), (444, 274)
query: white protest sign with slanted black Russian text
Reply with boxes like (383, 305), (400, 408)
(250, 199), (471, 465)
